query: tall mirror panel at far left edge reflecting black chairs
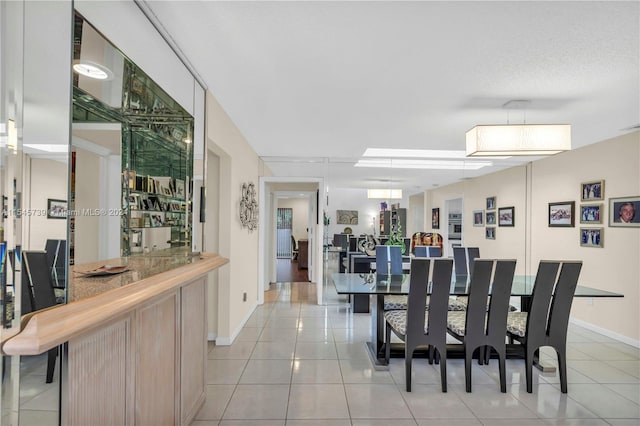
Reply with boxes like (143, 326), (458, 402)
(0, 2), (71, 425)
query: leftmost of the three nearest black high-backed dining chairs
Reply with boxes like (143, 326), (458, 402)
(384, 258), (453, 392)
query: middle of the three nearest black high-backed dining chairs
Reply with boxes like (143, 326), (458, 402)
(447, 259), (516, 393)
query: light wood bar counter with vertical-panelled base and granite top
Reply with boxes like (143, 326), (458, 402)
(2, 252), (228, 426)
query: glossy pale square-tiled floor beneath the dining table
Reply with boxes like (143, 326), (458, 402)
(192, 283), (640, 426)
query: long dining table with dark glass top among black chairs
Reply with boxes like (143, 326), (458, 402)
(331, 272), (624, 372)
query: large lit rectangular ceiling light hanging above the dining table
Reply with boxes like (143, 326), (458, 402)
(466, 124), (571, 157)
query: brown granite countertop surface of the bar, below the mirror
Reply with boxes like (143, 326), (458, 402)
(68, 248), (200, 302)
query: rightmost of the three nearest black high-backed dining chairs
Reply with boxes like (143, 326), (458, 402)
(507, 261), (582, 393)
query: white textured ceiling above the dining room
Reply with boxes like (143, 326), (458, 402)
(146, 0), (640, 193)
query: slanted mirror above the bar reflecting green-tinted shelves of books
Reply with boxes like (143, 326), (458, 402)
(70, 14), (193, 270)
